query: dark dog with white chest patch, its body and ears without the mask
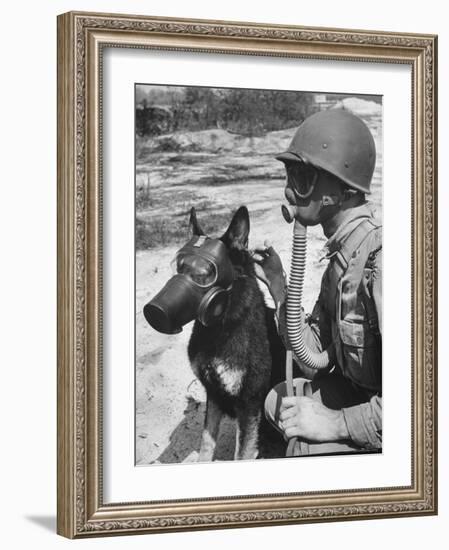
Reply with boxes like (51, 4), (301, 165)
(188, 206), (272, 462)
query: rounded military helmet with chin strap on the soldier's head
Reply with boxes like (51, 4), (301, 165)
(276, 109), (376, 193)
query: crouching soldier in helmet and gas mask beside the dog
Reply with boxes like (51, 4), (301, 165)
(256, 109), (382, 454)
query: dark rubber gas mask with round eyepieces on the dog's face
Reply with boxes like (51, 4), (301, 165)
(143, 235), (234, 334)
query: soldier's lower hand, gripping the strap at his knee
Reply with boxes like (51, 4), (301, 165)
(279, 396), (349, 443)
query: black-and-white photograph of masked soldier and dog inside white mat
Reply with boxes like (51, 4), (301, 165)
(135, 83), (383, 466)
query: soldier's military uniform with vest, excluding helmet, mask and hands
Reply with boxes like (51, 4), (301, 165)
(265, 204), (382, 454)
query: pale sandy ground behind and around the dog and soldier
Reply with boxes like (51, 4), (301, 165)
(136, 99), (382, 465)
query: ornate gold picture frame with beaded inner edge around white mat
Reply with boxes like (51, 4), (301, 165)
(57, 12), (437, 538)
